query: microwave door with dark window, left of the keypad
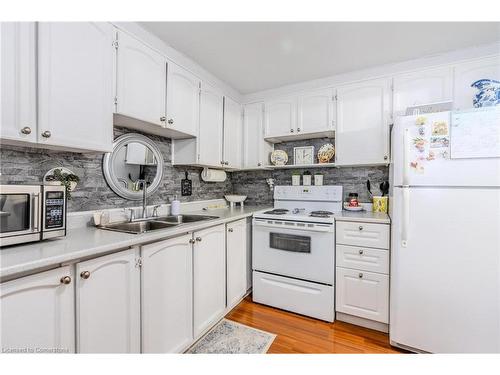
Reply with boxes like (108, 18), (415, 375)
(0, 185), (41, 246)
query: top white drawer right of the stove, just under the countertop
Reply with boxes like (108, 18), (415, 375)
(336, 221), (390, 249)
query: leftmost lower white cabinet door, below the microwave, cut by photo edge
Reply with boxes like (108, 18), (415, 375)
(0, 267), (75, 353)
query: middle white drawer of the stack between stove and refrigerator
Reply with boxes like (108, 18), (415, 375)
(336, 245), (389, 274)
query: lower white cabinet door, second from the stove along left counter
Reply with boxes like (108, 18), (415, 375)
(193, 224), (226, 339)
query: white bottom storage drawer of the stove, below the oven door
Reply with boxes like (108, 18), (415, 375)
(252, 271), (335, 322)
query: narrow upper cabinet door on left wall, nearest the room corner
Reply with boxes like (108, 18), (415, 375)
(223, 97), (243, 168)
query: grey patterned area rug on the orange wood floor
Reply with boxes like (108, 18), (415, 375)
(186, 319), (276, 354)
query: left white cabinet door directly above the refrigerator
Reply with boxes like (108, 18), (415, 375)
(393, 67), (453, 116)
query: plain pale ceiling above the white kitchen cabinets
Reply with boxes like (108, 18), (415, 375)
(141, 22), (500, 94)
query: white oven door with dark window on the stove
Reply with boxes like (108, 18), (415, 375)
(252, 219), (335, 285)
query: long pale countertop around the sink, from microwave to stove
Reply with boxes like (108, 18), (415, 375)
(0, 206), (270, 279)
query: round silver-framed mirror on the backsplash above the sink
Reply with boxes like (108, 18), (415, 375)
(102, 133), (163, 200)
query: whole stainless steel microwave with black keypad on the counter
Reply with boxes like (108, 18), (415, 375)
(0, 185), (66, 247)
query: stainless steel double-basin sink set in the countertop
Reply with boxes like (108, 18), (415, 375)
(97, 215), (219, 234)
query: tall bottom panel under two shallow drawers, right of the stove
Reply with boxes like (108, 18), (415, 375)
(335, 267), (389, 323)
